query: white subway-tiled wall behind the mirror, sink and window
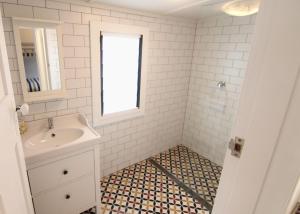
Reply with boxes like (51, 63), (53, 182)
(0, 0), (196, 176)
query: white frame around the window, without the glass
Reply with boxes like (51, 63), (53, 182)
(90, 21), (149, 126)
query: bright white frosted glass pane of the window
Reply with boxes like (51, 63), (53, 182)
(102, 34), (139, 115)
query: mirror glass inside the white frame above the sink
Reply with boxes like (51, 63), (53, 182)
(19, 28), (61, 92)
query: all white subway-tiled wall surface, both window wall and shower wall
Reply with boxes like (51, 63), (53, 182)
(0, 0), (255, 176)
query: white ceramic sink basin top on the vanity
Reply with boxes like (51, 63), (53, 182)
(22, 114), (100, 163)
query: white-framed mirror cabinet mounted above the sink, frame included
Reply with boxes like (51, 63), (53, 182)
(13, 18), (65, 102)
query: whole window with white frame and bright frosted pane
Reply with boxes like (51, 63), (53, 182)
(91, 22), (148, 126)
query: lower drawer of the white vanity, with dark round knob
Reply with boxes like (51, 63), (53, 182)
(33, 175), (96, 214)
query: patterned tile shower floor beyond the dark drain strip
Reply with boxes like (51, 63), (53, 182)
(152, 145), (222, 205)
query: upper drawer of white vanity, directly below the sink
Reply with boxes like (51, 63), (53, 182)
(28, 151), (94, 196)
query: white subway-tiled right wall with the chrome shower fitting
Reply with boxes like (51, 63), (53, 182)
(183, 15), (255, 164)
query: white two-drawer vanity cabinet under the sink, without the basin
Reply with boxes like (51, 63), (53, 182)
(27, 146), (100, 214)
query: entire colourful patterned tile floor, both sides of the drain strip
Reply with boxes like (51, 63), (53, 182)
(101, 145), (222, 214)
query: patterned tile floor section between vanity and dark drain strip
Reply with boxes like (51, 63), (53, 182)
(101, 160), (209, 214)
